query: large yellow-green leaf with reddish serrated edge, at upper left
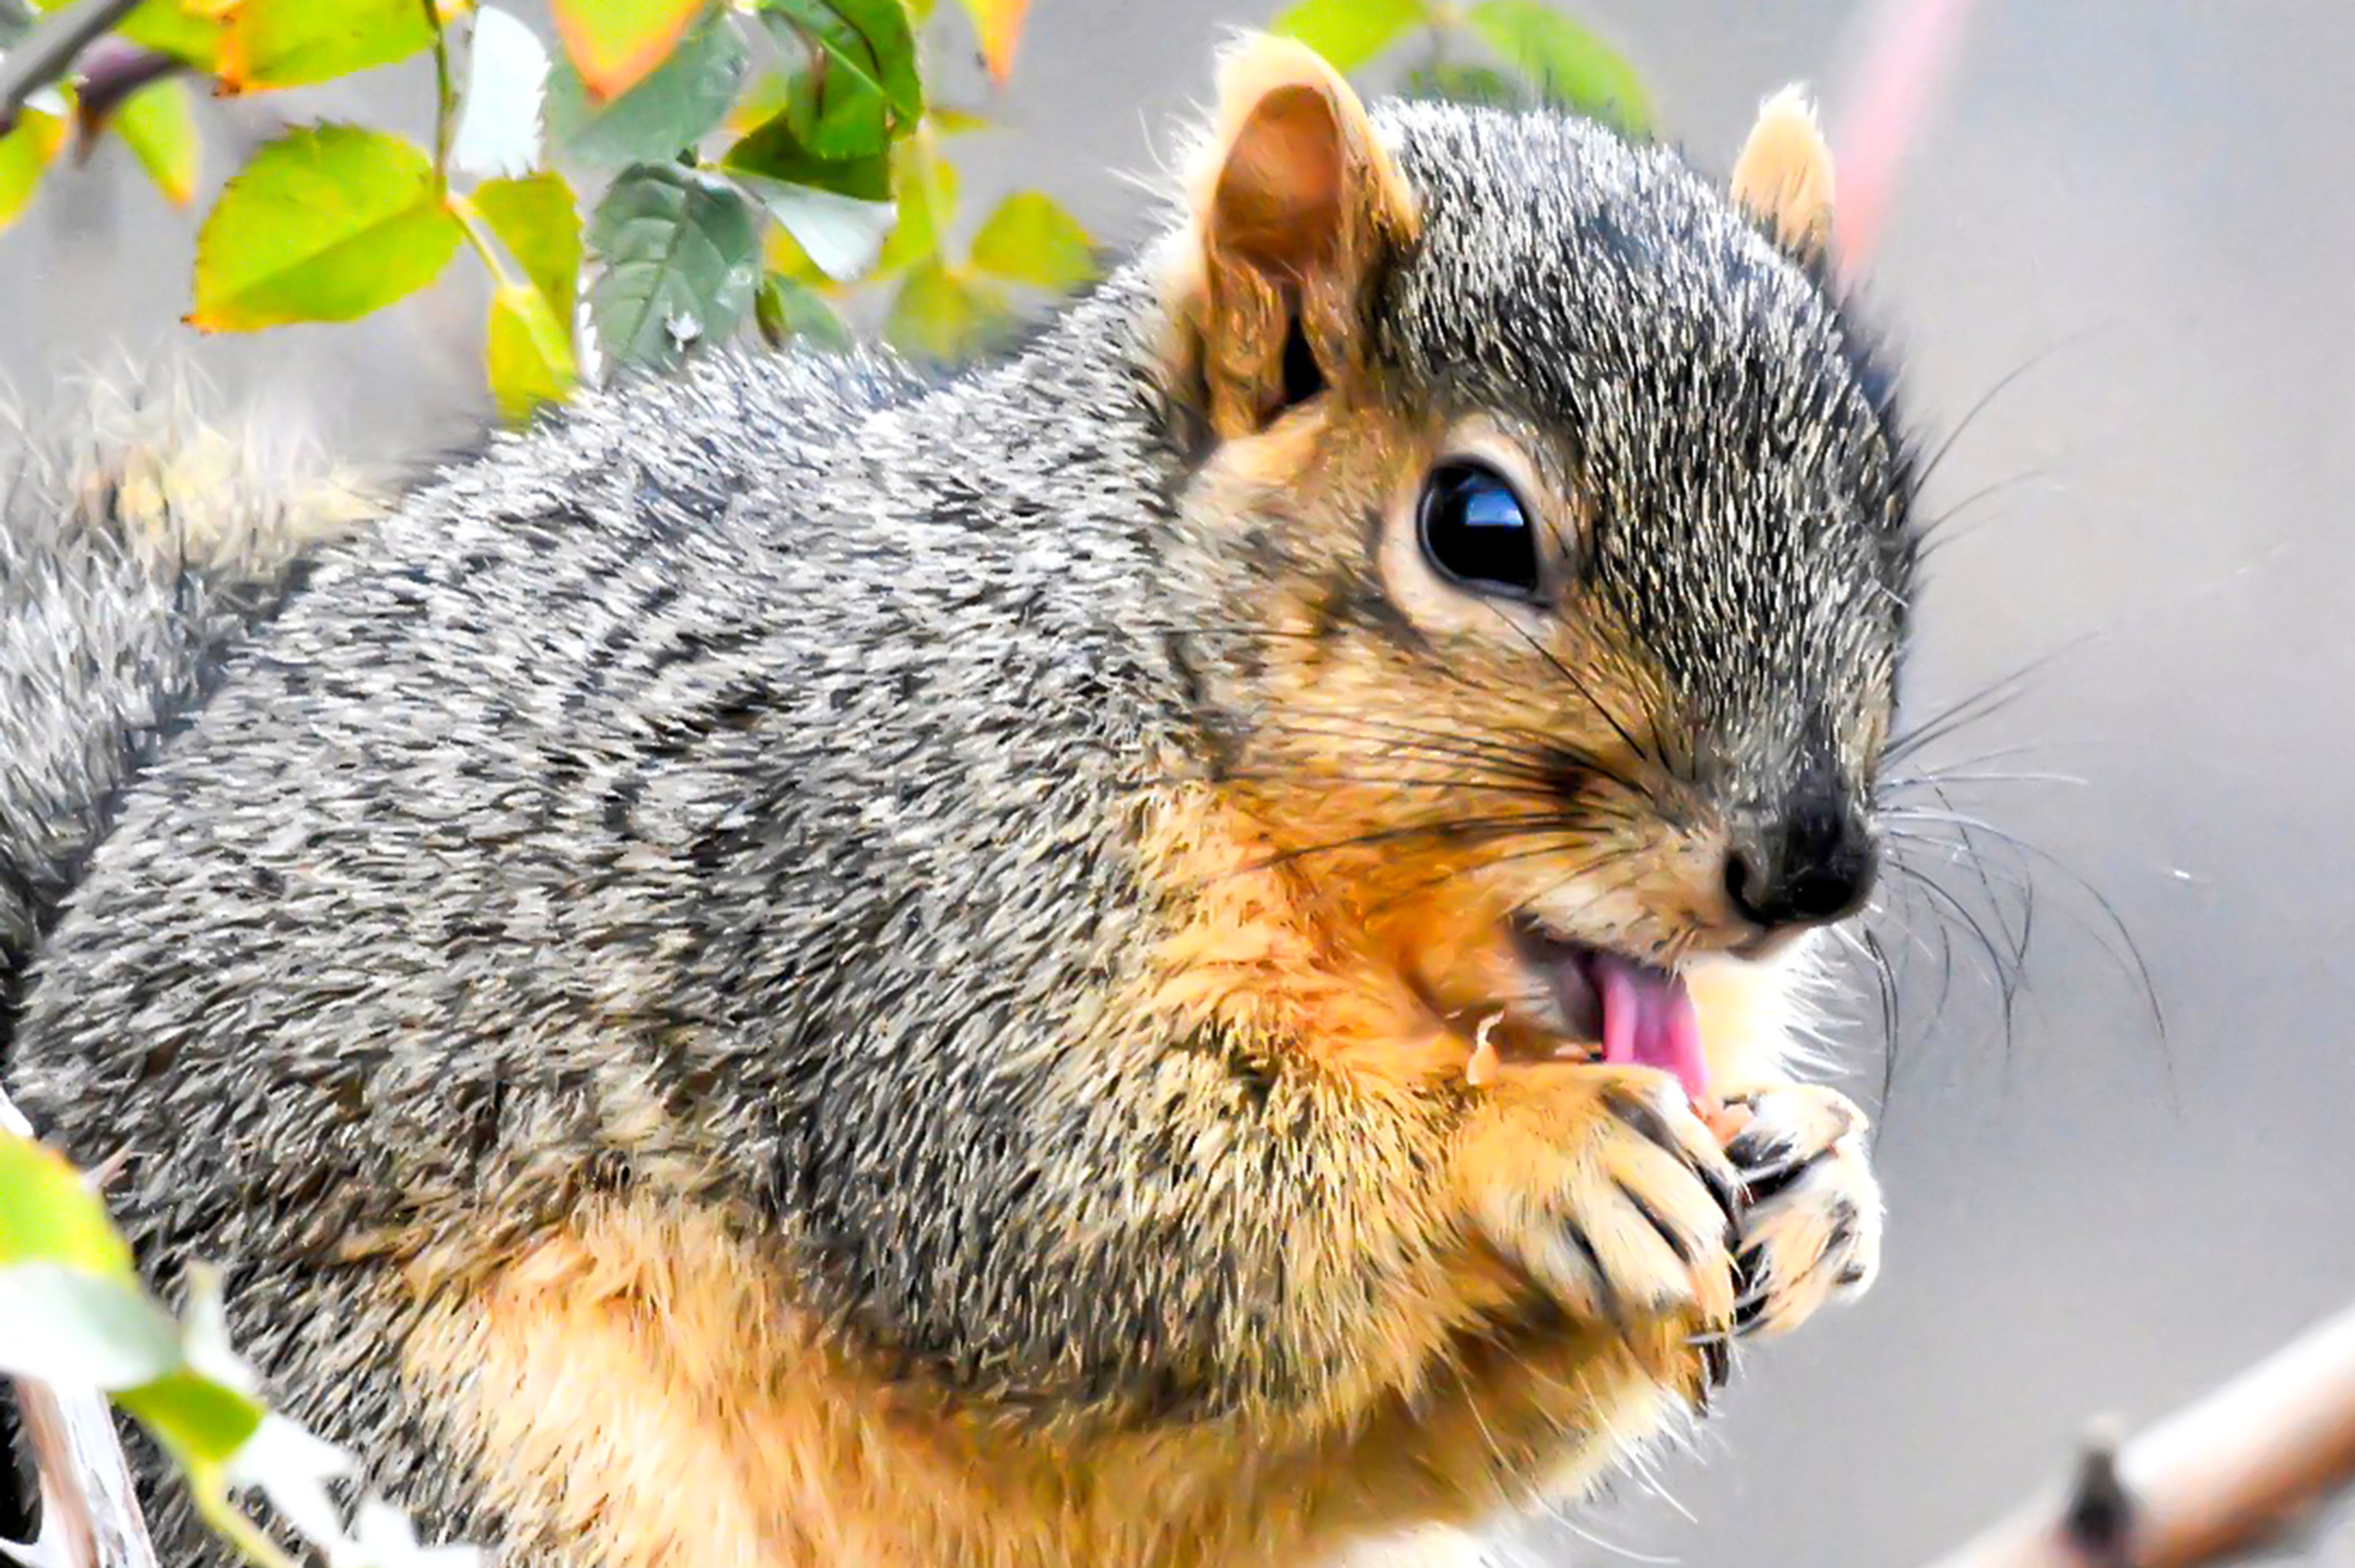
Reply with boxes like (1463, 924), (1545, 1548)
(188, 124), (462, 332)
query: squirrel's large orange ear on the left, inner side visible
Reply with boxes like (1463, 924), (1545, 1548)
(1178, 36), (1415, 435)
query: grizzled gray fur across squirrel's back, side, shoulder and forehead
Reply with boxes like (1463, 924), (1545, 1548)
(0, 109), (1903, 1563)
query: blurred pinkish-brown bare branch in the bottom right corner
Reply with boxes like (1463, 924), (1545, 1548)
(1936, 1309), (2355, 1568)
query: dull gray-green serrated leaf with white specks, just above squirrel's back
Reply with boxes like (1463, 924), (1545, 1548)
(589, 165), (760, 365)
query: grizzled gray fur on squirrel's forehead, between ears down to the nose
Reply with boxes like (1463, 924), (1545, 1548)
(1380, 110), (1912, 808)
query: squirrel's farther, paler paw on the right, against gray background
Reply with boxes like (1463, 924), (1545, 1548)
(1726, 1085), (1882, 1340)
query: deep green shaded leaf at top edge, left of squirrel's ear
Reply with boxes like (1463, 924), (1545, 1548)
(760, 0), (923, 160)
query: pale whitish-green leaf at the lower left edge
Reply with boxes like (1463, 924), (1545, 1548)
(0, 1261), (182, 1389)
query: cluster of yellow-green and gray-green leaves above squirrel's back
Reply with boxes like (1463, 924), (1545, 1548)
(0, 0), (1093, 419)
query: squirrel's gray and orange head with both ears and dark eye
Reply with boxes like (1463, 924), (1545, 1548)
(1163, 40), (1915, 1087)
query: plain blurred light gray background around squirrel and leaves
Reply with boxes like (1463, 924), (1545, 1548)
(0, 0), (2355, 1568)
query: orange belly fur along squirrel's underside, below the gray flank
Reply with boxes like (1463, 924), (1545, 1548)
(407, 1201), (1714, 1568)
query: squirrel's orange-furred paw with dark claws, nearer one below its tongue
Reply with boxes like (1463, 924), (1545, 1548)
(1469, 1066), (1740, 1326)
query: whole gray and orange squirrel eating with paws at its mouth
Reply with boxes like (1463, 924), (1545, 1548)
(0, 37), (1915, 1568)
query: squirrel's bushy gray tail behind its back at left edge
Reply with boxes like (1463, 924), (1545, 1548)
(0, 372), (393, 1036)
